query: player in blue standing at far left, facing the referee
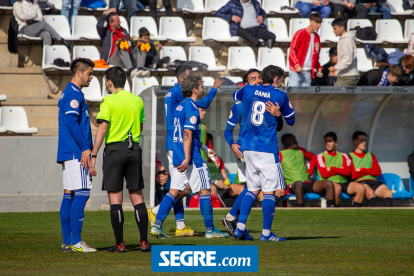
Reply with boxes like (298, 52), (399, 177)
(57, 58), (96, 253)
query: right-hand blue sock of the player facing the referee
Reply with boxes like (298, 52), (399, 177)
(70, 190), (90, 244)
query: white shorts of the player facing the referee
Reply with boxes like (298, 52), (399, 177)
(62, 159), (92, 191)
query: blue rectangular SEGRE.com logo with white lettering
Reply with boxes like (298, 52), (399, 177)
(151, 245), (259, 272)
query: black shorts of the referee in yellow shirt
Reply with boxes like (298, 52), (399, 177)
(102, 142), (144, 192)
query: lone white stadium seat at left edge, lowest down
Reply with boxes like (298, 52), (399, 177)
(0, 106), (37, 134)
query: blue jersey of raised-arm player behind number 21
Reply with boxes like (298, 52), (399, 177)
(164, 83), (217, 151)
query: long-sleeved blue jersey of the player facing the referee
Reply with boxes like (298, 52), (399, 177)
(57, 82), (92, 162)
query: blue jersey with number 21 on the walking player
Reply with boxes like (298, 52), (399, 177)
(173, 98), (204, 166)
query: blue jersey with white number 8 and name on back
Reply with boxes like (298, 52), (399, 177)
(233, 84), (295, 157)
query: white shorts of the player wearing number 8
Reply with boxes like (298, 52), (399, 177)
(244, 151), (285, 192)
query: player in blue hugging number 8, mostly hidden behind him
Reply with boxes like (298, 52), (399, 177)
(221, 69), (284, 234)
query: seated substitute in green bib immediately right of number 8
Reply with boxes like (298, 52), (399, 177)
(279, 133), (335, 207)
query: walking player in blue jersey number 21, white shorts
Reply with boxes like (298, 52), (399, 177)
(150, 75), (229, 238)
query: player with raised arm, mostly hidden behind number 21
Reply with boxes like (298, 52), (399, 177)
(148, 64), (224, 236)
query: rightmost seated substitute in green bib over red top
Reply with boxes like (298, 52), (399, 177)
(349, 130), (392, 207)
